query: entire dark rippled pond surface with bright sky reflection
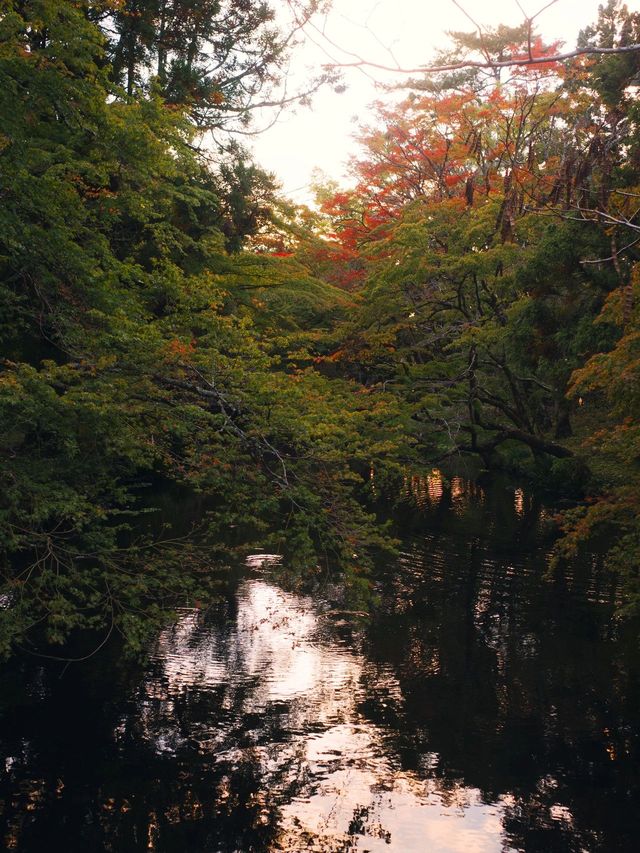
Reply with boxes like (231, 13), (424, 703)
(0, 475), (640, 853)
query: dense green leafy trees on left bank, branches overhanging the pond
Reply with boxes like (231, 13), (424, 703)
(0, 2), (401, 654)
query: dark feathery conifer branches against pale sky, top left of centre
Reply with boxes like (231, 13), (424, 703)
(96, 0), (336, 131)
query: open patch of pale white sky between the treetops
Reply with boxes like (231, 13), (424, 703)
(253, 0), (616, 202)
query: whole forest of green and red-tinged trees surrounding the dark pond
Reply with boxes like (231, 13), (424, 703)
(0, 0), (640, 659)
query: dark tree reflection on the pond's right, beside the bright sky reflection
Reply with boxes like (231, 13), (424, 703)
(367, 495), (640, 851)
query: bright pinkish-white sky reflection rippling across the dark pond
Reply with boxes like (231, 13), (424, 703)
(143, 579), (511, 853)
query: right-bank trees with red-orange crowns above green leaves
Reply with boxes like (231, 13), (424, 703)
(314, 0), (640, 607)
